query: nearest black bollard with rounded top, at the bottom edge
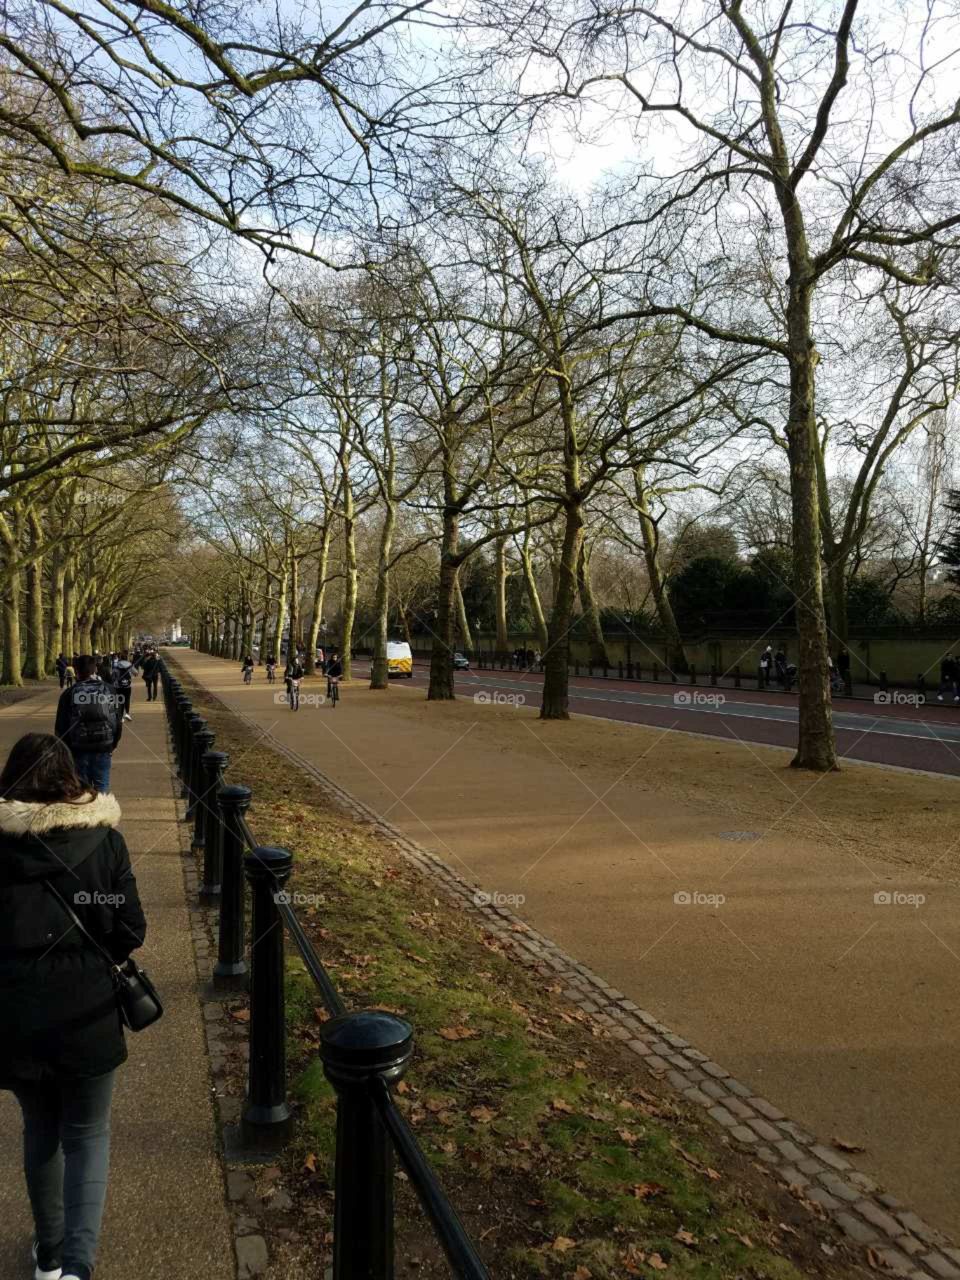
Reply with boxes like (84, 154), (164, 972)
(320, 1009), (413, 1280)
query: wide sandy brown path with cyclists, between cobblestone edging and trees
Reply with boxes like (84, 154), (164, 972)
(175, 652), (960, 1238)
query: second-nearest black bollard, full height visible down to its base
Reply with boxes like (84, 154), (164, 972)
(241, 845), (293, 1152)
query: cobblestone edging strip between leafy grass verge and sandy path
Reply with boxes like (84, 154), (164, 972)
(168, 670), (960, 1280)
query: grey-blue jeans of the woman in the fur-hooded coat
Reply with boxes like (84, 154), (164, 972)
(13, 1071), (115, 1280)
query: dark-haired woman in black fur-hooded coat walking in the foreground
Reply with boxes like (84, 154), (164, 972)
(0, 733), (146, 1280)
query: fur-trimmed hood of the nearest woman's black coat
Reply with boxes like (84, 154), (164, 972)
(0, 795), (120, 886)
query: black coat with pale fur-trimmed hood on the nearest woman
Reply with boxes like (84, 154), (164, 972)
(0, 795), (146, 1087)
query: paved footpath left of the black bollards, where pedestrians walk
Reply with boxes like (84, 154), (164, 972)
(0, 685), (236, 1280)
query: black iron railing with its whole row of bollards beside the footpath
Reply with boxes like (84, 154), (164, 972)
(160, 662), (488, 1280)
